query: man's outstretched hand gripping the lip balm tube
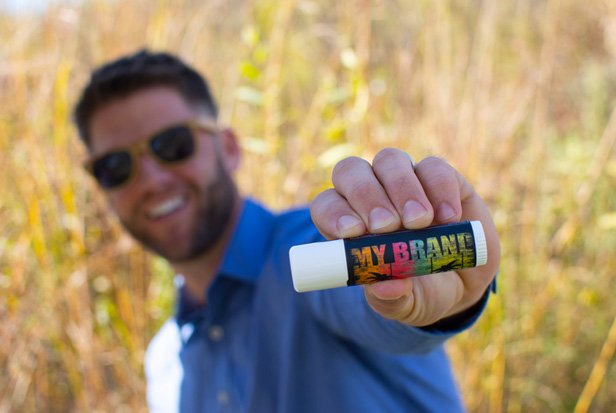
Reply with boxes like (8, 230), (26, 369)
(310, 149), (500, 327)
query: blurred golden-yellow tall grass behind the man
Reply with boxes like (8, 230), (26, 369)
(0, 0), (616, 413)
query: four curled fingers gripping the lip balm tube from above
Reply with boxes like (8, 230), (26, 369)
(311, 149), (472, 238)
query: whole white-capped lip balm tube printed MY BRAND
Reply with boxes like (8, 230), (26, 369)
(289, 221), (488, 293)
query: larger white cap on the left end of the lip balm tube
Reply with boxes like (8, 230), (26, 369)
(289, 239), (349, 293)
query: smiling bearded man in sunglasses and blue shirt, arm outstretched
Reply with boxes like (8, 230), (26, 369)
(75, 51), (500, 412)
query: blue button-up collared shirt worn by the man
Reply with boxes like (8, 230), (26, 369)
(145, 200), (488, 413)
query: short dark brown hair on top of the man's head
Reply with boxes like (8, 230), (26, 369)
(74, 50), (218, 147)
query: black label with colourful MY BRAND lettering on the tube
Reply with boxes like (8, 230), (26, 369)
(344, 221), (477, 285)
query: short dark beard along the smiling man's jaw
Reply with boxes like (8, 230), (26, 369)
(122, 158), (236, 262)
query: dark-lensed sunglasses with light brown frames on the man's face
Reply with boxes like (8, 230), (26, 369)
(84, 119), (218, 189)
